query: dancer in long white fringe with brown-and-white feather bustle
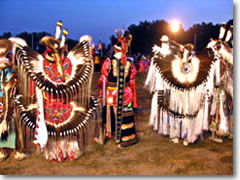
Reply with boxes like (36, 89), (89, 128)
(145, 35), (216, 145)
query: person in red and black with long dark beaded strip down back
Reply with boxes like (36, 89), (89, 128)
(99, 30), (137, 147)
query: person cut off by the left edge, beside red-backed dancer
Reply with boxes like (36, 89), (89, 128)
(0, 38), (27, 161)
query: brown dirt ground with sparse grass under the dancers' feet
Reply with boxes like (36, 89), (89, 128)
(0, 73), (234, 175)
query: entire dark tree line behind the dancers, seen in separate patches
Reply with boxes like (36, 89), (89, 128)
(0, 19), (233, 55)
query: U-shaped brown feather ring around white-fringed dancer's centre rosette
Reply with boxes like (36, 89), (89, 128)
(153, 49), (214, 90)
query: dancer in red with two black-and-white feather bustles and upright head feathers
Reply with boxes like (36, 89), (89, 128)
(15, 21), (98, 161)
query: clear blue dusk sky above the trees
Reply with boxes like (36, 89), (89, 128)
(0, 0), (233, 43)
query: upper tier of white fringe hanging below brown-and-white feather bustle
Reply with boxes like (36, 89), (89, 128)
(145, 60), (215, 116)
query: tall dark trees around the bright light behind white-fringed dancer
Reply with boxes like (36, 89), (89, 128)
(110, 19), (233, 55)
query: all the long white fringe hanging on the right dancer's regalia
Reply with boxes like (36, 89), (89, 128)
(145, 61), (217, 143)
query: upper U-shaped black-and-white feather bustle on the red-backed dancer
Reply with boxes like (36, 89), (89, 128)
(16, 41), (93, 101)
